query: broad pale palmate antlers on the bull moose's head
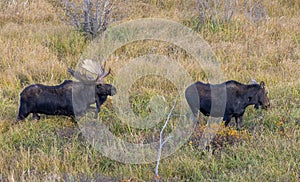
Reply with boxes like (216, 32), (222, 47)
(68, 59), (110, 84)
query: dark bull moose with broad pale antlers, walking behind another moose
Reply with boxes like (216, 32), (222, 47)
(16, 59), (116, 122)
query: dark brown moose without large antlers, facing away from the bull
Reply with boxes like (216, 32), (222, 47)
(185, 80), (270, 129)
